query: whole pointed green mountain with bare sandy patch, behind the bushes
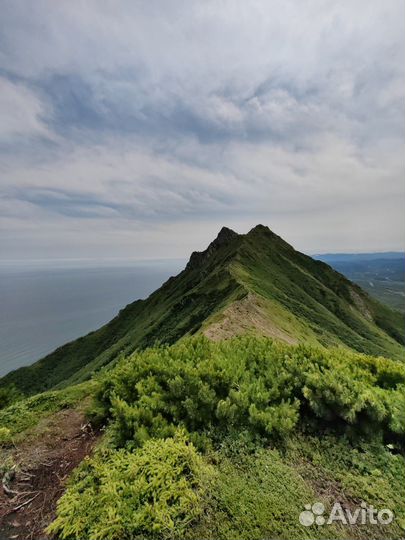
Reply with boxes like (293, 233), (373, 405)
(0, 225), (405, 394)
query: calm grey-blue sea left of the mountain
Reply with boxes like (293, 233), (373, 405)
(0, 261), (184, 376)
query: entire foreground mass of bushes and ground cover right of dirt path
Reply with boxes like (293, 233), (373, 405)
(45, 337), (405, 540)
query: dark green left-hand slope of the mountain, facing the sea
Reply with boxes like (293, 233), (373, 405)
(0, 233), (241, 394)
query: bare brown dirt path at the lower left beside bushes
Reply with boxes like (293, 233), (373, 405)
(0, 409), (97, 540)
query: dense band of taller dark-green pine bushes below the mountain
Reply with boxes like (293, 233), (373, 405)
(97, 337), (405, 447)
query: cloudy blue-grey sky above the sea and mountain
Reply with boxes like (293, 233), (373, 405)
(0, 0), (405, 261)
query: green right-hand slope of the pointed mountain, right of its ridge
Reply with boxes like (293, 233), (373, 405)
(227, 227), (405, 359)
